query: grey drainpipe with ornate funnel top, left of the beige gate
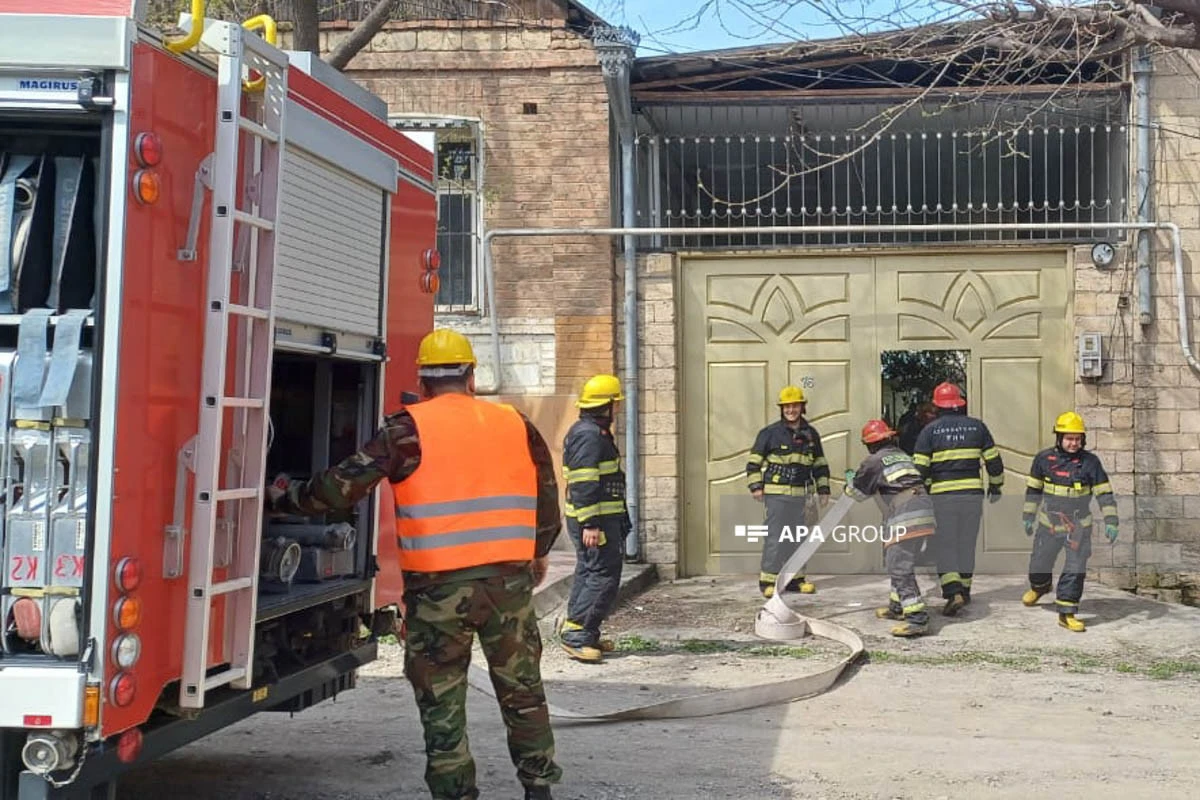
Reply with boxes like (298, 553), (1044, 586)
(592, 26), (642, 561)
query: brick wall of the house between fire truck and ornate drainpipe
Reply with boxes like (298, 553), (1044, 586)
(285, 1), (613, 395)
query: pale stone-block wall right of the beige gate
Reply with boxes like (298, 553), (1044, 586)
(1075, 54), (1200, 604)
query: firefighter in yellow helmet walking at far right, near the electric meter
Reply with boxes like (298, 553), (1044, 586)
(1021, 411), (1117, 633)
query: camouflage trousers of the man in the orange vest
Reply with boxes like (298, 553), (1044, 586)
(404, 571), (563, 800)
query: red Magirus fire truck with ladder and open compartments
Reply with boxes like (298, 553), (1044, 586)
(0, 0), (438, 800)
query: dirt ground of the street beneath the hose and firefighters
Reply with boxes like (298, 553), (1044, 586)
(118, 578), (1200, 800)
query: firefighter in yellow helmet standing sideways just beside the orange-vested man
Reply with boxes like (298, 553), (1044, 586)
(559, 375), (630, 662)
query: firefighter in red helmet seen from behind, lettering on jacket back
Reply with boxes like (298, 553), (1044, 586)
(912, 383), (1004, 616)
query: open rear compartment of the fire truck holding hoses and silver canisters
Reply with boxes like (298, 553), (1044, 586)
(0, 109), (106, 661)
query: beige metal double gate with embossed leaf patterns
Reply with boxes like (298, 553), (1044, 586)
(679, 249), (1074, 575)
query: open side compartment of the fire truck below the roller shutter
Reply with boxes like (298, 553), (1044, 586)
(258, 351), (378, 621)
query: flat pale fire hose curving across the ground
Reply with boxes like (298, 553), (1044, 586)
(468, 494), (864, 723)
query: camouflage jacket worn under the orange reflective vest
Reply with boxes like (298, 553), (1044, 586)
(274, 402), (563, 582)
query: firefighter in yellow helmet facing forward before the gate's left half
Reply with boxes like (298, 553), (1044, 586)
(746, 386), (829, 597)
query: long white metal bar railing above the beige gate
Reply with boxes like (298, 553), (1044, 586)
(637, 92), (1129, 248)
